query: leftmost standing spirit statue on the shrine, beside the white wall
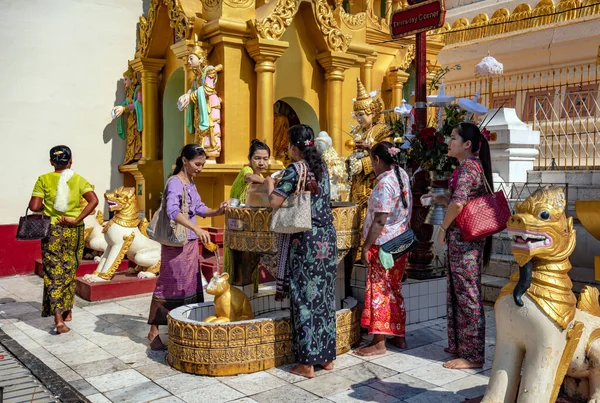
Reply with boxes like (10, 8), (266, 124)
(111, 67), (142, 164)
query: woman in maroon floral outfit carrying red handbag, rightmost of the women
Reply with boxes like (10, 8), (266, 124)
(424, 123), (493, 369)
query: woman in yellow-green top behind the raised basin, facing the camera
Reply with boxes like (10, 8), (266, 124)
(223, 139), (271, 280)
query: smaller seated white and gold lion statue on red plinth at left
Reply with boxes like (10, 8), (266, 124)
(83, 186), (160, 282)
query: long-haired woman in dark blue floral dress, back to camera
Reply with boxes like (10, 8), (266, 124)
(267, 125), (337, 378)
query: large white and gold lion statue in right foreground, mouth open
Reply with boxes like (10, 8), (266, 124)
(482, 187), (600, 403)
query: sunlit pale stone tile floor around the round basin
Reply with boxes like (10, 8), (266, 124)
(0, 276), (495, 403)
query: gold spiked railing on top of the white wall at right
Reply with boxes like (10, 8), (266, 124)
(446, 64), (600, 169)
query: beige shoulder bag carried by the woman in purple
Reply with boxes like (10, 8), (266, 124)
(147, 176), (189, 247)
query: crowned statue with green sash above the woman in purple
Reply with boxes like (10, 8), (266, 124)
(177, 38), (223, 159)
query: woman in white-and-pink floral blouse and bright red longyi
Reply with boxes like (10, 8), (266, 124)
(356, 141), (412, 356)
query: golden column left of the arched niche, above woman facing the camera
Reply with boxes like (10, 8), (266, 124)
(246, 38), (290, 164)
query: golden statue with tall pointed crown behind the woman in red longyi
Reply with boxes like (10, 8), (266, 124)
(346, 78), (393, 228)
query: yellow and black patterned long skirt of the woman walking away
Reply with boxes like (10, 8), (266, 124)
(42, 225), (84, 316)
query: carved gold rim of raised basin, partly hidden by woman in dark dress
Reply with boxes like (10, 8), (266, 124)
(223, 204), (360, 254)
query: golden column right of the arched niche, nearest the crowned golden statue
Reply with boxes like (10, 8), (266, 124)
(317, 52), (358, 155)
